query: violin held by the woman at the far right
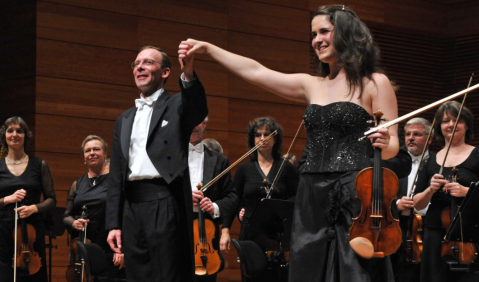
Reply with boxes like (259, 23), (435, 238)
(441, 167), (476, 264)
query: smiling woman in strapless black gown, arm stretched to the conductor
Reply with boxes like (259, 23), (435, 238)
(178, 5), (399, 282)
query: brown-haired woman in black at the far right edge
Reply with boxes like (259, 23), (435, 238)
(413, 101), (479, 282)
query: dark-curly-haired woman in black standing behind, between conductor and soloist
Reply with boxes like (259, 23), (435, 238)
(234, 117), (298, 282)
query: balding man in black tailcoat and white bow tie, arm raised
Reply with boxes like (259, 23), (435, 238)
(106, 46), (208, 282)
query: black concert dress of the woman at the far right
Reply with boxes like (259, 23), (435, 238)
(414, 148), (479, 282)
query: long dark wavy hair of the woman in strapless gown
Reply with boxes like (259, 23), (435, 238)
(313, 5), (384, 98)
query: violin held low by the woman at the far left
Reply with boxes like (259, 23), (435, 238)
(12, 204), (42, 276)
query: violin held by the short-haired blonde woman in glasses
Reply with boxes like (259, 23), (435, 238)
(65, 206), (94, 282)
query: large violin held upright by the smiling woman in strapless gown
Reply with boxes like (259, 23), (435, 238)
(349, 109), (402, 259)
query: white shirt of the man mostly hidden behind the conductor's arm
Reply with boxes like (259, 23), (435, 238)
(188, 142), (220, 218)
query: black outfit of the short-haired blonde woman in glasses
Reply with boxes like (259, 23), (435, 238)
(63, 173), (124, 281)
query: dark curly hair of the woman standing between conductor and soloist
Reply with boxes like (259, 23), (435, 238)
(246, 117), (283, 161)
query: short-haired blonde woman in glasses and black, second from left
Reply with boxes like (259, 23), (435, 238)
(63, 135), (123, 281)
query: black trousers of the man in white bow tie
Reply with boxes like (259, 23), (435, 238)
(122, 178), (193, 282)
